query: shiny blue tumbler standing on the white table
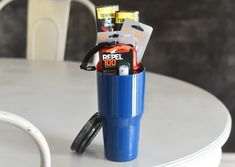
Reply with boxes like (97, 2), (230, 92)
(97, 70), (145, 162)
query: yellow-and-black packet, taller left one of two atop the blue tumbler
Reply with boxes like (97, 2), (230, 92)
(96, 5), (119, 32)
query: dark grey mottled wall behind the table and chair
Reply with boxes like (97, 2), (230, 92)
(0, 0), (235, 151)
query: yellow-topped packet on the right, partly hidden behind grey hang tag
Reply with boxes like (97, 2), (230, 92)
(115, 11), (139, 31)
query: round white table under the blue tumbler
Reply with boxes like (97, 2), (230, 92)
(0, 59), (231, 167)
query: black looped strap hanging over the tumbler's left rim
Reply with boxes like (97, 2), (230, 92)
(80, 42), (116, 71)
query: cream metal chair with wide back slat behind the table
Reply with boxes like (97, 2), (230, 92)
(0, 0), (95, 61)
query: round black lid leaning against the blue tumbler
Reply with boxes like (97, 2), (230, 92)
(71, 112), (102, 154)
